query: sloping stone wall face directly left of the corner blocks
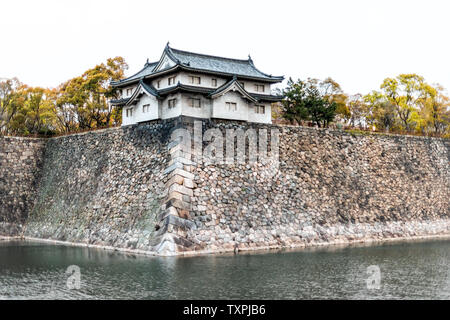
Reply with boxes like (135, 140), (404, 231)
(25, 121), (181, 251)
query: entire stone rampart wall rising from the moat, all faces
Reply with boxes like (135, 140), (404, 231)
(0, 118), (450, 255)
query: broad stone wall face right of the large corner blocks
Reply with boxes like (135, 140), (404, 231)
(184, 122), (450, 251)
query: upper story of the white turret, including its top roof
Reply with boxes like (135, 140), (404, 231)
(112, 44), (284, 99)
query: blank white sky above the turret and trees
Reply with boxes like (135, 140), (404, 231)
(0, 0), (450, 94)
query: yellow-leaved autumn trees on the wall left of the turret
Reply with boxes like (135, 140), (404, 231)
(0, 57), (128, 135)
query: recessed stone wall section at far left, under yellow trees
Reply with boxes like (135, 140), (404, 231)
(0, 137), (46, 236)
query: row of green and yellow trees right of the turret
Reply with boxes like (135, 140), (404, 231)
(282, 73), (450, 137)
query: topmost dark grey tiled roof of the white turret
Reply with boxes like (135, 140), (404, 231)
(111, 45), (284, 85)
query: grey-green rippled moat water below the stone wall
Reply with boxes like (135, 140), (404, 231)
(0, 240), (450, 299)
